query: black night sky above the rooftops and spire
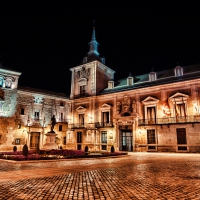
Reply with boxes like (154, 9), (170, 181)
(0, 1), (200, 94)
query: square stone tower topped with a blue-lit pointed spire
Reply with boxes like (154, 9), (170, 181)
(70, 27), (115, 99)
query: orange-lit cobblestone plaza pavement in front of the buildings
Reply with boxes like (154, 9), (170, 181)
(0, 153), (200, 200)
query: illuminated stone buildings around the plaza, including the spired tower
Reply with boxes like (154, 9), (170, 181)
(0, 26), (200, 152)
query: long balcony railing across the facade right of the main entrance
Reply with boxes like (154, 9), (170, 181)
(138, 115), (200, 126)
